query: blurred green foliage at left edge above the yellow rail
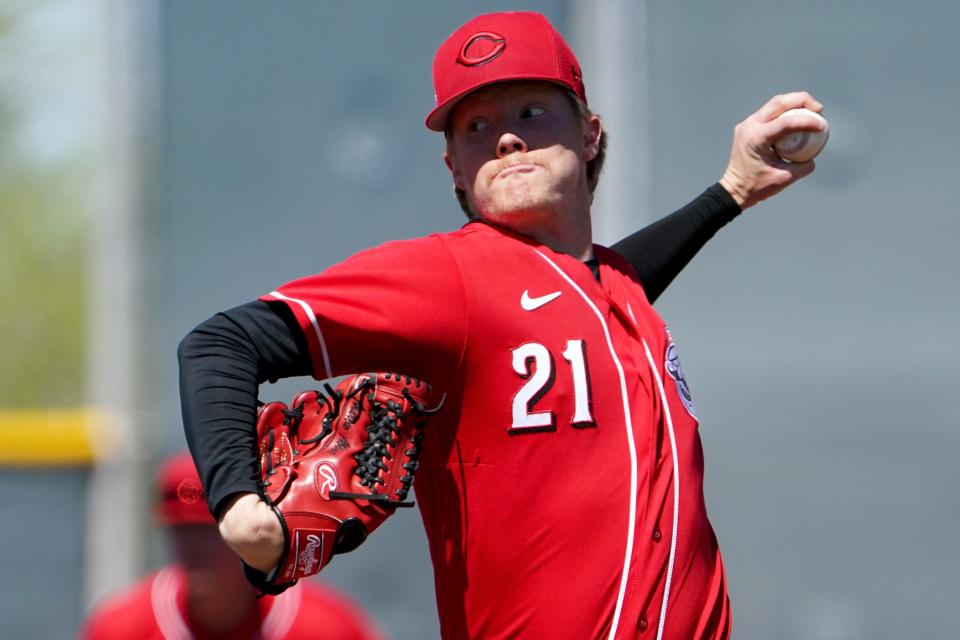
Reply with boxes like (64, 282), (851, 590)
(0, 159), (90, 408)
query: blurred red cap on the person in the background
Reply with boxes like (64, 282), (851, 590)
(154, 452), (217, 526)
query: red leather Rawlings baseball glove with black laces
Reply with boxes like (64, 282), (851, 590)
(246, 373), (442, 594)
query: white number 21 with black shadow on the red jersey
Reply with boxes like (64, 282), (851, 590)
(509, 340), (596, 434)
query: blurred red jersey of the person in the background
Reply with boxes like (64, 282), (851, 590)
(80, 566), (381, 640)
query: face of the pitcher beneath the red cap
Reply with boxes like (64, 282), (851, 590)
(446, 82), (600, 235)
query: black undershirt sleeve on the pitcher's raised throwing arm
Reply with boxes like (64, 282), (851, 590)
(611, 183), (741, 304)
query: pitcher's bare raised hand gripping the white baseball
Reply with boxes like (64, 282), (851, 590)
(720, 91), (823, 209)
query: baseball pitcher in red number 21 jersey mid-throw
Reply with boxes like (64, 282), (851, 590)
(179, 12), (822, 640)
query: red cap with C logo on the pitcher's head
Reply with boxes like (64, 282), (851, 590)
(426, 11), (587, 131)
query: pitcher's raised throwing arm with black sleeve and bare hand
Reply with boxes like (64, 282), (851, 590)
(612, 91), (823, 303)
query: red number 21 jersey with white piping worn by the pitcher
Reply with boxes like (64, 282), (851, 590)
(262, 222), (730, 640)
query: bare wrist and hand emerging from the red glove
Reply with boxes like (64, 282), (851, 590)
(214, 493), (284, 573)
